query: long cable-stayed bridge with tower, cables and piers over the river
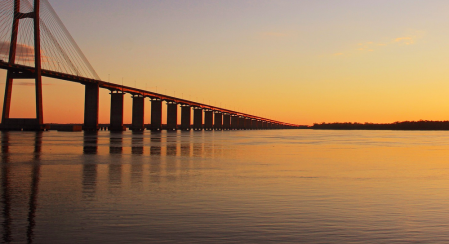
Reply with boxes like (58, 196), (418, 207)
(0, 0), (299, 131)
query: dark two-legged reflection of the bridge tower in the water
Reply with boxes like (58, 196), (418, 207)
(1, 132), (43, 243)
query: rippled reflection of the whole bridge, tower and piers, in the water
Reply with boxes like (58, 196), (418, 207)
(1, 131), (222, 243)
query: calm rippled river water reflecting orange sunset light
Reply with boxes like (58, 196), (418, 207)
(0, 130), (449, 243)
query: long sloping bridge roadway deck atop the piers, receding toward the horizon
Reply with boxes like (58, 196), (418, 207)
(0, 60), (298, 128)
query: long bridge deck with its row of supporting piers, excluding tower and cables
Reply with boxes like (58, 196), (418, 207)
(0, 61), (298, 131)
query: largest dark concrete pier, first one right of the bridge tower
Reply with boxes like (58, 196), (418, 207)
(83, 84), (100, 131)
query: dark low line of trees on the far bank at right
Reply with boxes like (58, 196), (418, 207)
(309, 120), (449, 130)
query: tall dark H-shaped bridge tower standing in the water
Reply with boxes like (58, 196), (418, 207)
(1, 0), (44, 130)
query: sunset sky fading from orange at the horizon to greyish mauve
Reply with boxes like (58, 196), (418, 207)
(0, 0), (449, 125)
